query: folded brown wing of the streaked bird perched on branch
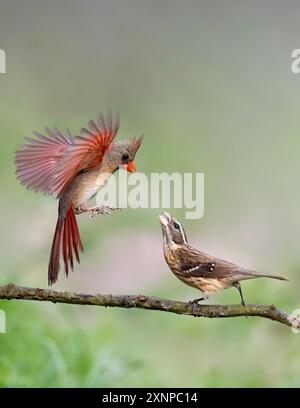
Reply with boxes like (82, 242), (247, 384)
(176, 247), (242, 278)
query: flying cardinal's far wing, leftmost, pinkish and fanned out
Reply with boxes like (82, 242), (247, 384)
(15, 128), (73, 194)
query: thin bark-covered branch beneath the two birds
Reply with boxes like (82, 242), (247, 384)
(0, 283), (300, 329)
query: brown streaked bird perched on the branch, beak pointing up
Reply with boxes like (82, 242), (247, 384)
(159, 212), (288, 305)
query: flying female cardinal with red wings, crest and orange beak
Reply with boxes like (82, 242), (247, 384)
(15, 112), (143, 285)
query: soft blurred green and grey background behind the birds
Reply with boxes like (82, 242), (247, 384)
(0, 0), (300, 387)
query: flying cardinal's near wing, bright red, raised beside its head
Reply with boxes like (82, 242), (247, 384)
(51, 111), (119, 196)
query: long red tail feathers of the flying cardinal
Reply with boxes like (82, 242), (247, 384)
(48, 207), (83, 285)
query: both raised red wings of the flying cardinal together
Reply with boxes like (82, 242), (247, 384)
(15, 111), (119, 196)
